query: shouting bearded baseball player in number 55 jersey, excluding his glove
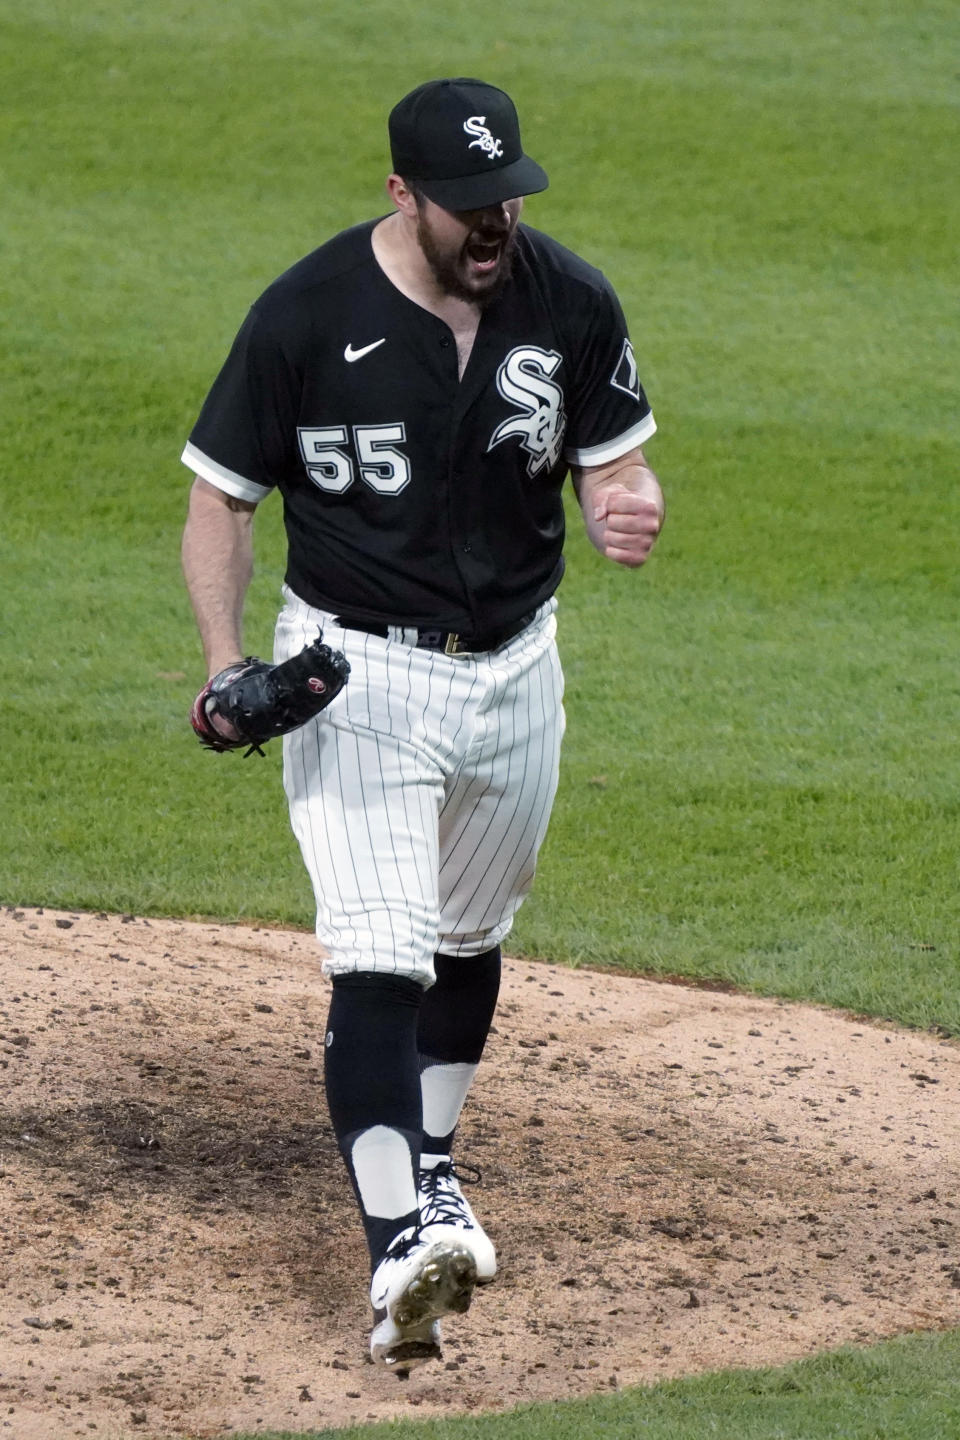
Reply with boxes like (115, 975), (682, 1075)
(183, 79), (664, 1374)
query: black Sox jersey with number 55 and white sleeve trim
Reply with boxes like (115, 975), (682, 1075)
(183, 222), (656, 634)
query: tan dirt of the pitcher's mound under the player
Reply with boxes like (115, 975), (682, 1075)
(0, 907), (960, 1440)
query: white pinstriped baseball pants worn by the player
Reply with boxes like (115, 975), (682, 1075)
(273, 588), (564, 985)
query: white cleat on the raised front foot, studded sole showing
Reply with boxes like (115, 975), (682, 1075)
(370, 1230), (476, 1377)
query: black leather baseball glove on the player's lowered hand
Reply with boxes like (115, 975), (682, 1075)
(190, 631), (350, 755)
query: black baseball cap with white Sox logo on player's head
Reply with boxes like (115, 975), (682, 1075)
(390, 78), (550, 210)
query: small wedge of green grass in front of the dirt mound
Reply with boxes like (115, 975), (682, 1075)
(236, 1333), (960, 1440)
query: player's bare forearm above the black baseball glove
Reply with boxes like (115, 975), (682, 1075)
(181, 480), (253, 675)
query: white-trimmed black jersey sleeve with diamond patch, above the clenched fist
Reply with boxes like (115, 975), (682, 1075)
(564, 279), (656, 467)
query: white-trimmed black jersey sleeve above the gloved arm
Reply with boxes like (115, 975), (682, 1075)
(181, 305), (301, 503)
